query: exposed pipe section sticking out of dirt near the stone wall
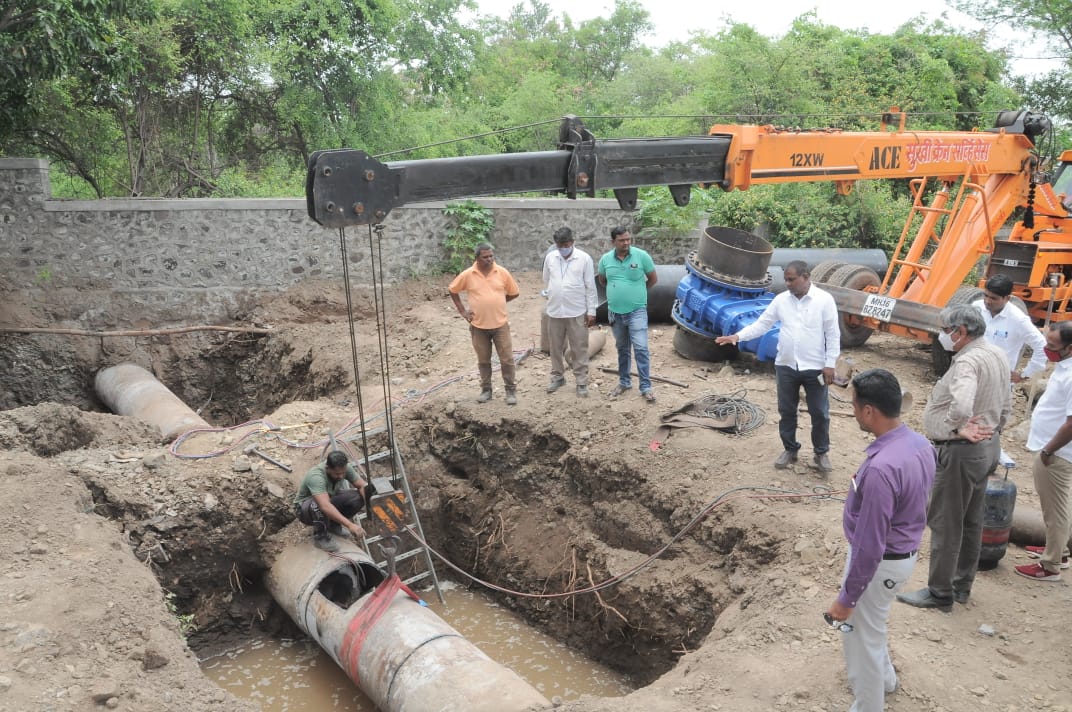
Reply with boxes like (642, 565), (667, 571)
(94, 364), (211, 440)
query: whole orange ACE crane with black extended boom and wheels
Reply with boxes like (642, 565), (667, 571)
(307, 108), (1072, 370)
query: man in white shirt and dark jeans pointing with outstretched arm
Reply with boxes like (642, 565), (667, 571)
(715, 259), (842, 474)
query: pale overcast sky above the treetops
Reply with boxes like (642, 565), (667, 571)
(476, 0), (1059, 75)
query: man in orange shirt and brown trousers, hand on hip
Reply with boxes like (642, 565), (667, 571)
(448, 242), (521, 405)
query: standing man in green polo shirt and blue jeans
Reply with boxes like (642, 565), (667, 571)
(598, 227), (658, 403)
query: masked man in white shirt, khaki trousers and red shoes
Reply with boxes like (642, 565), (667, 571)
(1015, 323), (1072, 581)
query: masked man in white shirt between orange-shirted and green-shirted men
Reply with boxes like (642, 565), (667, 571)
(544, 227), (596, 398)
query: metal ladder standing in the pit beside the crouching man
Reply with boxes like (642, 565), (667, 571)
(347, 428), (446, 604)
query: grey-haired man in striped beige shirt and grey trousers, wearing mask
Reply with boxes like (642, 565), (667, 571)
(897, 305), (1012, 612)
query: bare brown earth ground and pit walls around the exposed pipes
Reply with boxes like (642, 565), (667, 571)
(0, 273), (1072, 712)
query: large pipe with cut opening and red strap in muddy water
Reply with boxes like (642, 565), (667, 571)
(266, 539), (551, 712)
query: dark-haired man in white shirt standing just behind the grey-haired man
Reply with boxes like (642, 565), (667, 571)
(973, 275), (1046, 383)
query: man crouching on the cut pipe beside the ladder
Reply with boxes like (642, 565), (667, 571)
(294, 450), (375, 551)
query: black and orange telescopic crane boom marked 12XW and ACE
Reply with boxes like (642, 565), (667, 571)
(306, 112), (1049, 227)
